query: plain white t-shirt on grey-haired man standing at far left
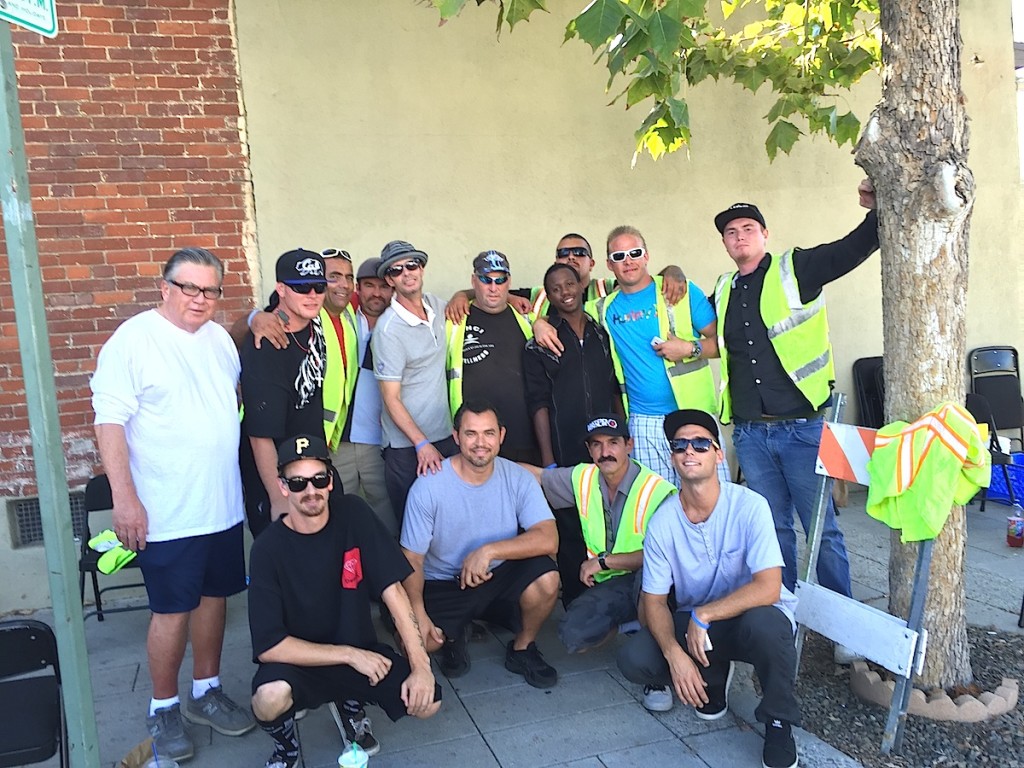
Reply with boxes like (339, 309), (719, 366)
(90, 309), (243, 542)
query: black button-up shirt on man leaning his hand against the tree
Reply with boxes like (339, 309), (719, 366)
(723, 211), (879, 421)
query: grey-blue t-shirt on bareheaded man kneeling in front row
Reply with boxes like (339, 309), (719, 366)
(401, 458), (555, 581)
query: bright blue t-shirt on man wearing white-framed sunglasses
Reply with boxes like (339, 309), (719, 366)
(607, 281), (715, 416)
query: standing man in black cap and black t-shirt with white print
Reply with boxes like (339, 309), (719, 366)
(241, 248), (328, 536)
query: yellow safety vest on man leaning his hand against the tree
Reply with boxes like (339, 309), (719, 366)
(715, 249), (836, 424)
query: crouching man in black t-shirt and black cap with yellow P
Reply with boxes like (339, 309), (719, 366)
(249, 435), (440, 768)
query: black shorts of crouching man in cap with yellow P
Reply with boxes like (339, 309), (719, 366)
(253, 643), (441, 720)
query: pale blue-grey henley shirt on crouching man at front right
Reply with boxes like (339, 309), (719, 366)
(643, 482), (797, 626)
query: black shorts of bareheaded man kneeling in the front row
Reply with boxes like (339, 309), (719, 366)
(423, 555), (555, 637)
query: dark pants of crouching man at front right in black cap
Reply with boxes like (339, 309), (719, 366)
(616, 605), (800, 725)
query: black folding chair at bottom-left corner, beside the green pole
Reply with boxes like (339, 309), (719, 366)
(0, 618), (69, 768)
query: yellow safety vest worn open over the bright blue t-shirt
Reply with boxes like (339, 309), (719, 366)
(586, 275), (721, 415)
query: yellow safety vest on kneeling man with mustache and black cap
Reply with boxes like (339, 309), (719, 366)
(572, 459), (676, 582)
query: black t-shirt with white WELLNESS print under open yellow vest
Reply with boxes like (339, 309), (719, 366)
(462, 306), (537, 459)
